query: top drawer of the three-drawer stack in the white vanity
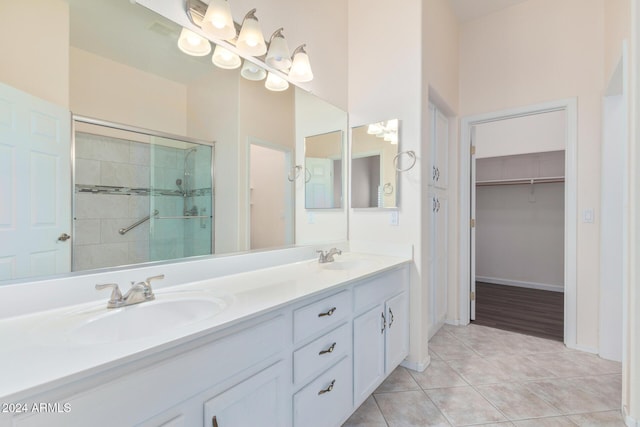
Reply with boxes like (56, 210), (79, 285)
(293, 291), (351, 342)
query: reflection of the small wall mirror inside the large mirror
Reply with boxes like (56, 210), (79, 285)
(304, 130), (344, 209)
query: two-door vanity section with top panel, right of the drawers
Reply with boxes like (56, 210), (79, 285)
(353, 268), (409, 407)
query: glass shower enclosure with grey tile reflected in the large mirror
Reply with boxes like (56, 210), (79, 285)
(72, 116), (215, 271)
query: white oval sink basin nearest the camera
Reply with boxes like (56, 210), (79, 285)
(50, 292), (229, 344)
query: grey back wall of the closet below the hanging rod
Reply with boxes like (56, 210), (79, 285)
(476, 183), (564, 291)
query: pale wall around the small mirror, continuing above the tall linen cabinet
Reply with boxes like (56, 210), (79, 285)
(348, 0), (458, 367)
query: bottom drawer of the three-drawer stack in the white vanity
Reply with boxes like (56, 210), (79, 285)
(293, 357), (353, 427)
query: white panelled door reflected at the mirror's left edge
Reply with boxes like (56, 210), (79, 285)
(0, 84), (71, 280)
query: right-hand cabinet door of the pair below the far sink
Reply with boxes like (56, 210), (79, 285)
(385, 292), (409, 374)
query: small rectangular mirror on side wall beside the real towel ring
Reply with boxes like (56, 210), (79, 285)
(351, 119), (400, 208)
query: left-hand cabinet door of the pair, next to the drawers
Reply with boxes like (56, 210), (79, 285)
(353, 304), (386, 406)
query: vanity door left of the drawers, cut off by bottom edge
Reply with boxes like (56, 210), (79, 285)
(204, 362), (287, 427)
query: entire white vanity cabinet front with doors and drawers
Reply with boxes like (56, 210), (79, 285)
(0, 263), (409, 427)
